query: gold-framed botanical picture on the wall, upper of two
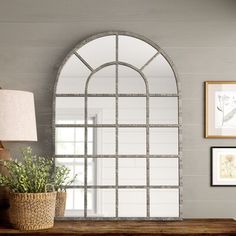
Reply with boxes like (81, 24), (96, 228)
(205, 81), (236, 138)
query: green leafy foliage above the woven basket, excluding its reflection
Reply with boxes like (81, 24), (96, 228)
(0, 147), (53, 193)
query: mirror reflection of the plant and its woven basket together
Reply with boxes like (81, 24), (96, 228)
(53, 165), (77, 217)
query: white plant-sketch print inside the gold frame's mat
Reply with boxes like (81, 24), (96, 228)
(215, 91), (236, 128)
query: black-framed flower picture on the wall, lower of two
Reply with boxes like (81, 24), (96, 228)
(211, 147), (236, 186)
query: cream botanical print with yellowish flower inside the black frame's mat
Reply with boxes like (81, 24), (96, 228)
(219, 154), (236, 179)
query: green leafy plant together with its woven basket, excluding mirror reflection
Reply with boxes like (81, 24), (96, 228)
(0, 147), (56, 230)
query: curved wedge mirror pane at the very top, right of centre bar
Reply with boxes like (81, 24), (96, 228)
(119, 35), (157, 69)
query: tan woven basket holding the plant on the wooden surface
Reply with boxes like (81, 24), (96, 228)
(9, 192), (56, 230)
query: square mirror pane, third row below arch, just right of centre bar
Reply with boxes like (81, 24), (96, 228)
(118, 158), (146, 185)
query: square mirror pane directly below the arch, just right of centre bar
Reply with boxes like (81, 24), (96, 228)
(118, 97), (146, 124)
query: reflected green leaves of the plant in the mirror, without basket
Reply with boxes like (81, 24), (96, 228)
(53, 165), (77, 191)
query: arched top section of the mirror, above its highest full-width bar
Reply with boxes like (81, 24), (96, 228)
(55, 32), (178, 94)
